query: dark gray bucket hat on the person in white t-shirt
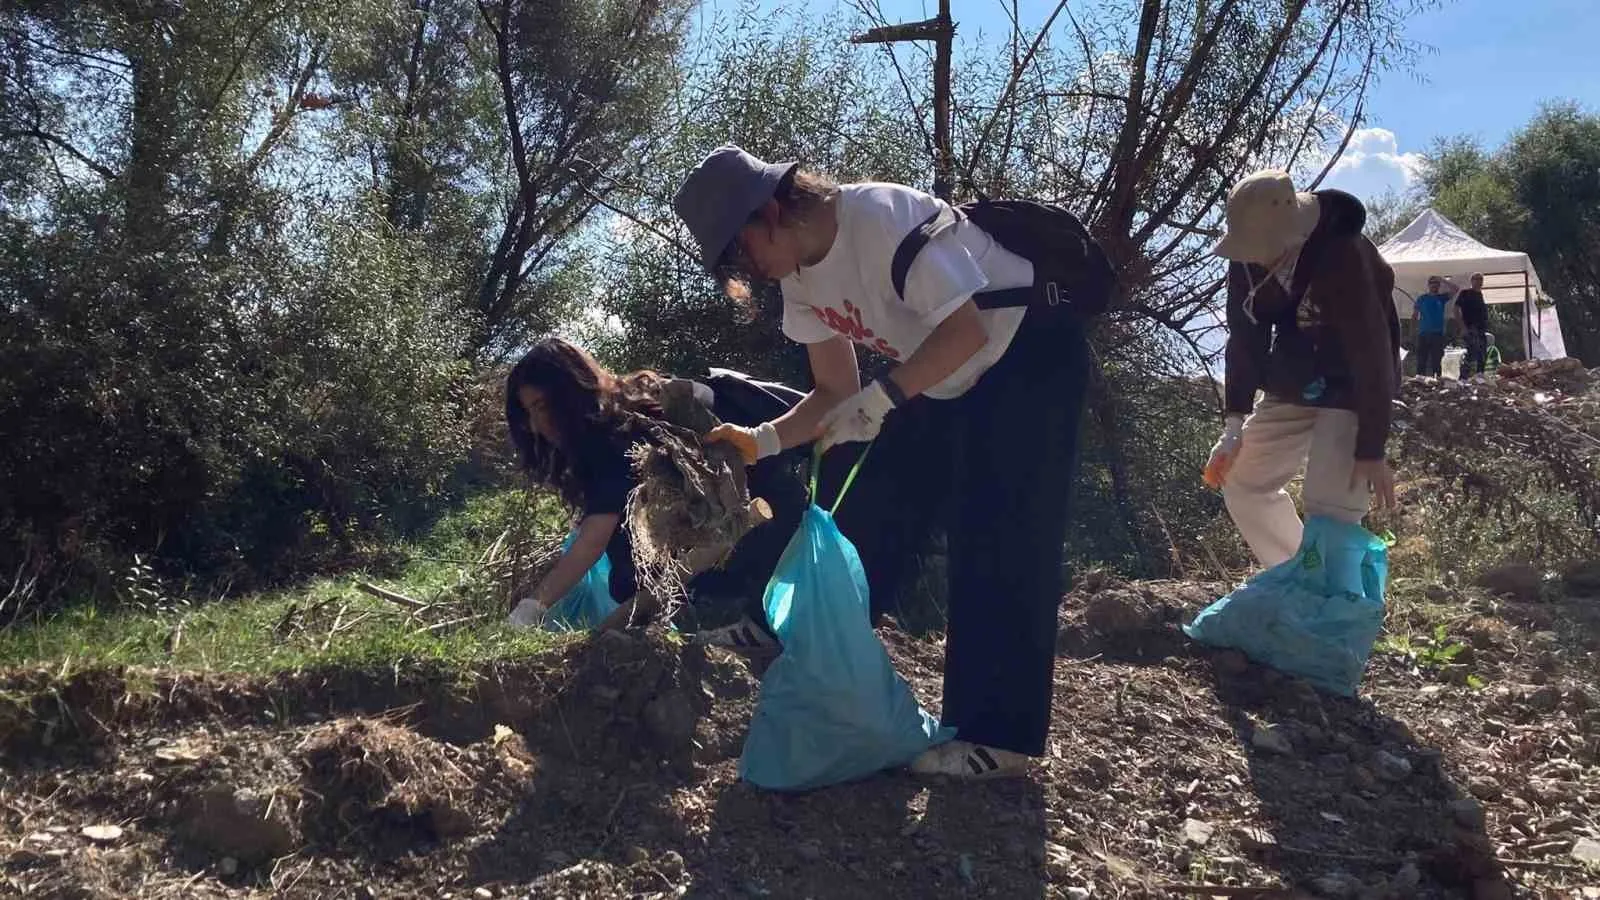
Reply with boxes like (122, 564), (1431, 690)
(672, 144), (800, 271)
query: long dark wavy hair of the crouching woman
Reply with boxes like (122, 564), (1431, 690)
(506, 338), (664, 508)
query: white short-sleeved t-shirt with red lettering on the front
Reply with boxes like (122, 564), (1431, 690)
(779, 183), (1034, 400)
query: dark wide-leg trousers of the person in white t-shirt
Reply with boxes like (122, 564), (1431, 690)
(822, 307), (1090, 756)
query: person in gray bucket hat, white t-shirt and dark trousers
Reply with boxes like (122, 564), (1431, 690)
(674, 146), (1090, 778)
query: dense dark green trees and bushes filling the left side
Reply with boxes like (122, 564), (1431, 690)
(0, 0), (686, 611)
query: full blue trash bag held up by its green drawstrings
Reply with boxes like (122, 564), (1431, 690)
(739, 445), (954, 791)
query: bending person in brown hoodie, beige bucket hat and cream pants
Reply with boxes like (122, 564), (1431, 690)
(1206, 170), (1400, 567)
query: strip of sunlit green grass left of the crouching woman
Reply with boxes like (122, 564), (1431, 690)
(0, 490), (566, 674)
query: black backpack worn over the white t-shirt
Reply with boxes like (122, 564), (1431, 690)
(891, 199), (1117, 319)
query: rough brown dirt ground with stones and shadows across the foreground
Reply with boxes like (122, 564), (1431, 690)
(0, 578), (1600, 898)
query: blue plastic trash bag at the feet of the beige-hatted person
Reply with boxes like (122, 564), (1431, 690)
(1184, 516), (1389, 697)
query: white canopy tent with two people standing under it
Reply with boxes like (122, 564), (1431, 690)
(1378, 210), (1566, 359)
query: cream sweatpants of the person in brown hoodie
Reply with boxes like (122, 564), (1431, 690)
(1222, 399), (1371, 569)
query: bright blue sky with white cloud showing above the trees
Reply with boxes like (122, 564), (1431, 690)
(707, 0), (1600, 197)
